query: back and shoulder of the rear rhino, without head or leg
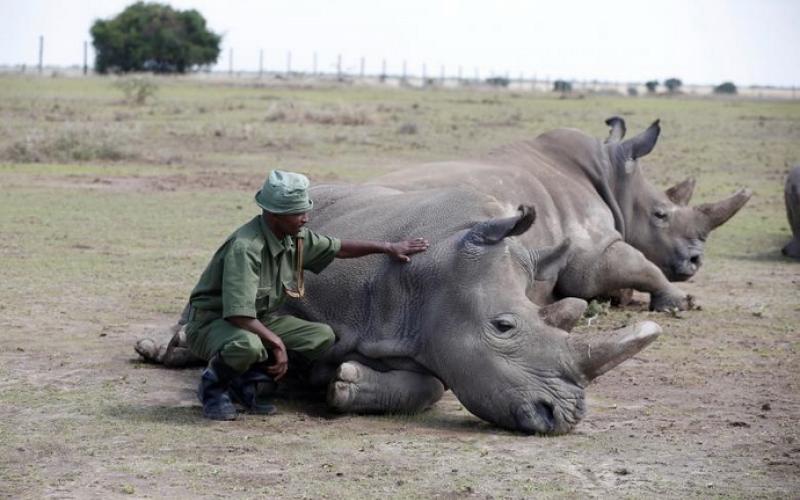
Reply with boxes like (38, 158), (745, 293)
(375, 129), (620, 251)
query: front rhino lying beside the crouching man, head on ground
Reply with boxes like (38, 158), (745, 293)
(139, 186), (660, 434)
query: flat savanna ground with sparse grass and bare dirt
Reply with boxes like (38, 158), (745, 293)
(0, 76), (800, 498)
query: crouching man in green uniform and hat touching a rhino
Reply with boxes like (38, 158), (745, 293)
(186, 170), (428, 420)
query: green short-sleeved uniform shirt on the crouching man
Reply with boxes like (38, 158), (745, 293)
(190, 215), (342, 319)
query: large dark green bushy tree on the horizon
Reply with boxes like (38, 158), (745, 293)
(91, 2), (222, 73)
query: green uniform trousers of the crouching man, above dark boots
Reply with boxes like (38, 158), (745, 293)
(186, 310), (336, 373)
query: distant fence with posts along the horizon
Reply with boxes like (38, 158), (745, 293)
(0, 36), (797, 100)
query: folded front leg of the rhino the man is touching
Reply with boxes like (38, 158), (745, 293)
(328, 361), (444, 413)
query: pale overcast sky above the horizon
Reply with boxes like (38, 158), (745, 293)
(0, 0), (800, 86)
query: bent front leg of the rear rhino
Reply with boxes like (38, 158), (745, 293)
(558, 241), (689, 311)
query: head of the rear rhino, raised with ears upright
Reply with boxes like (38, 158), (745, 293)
(605, 117), (752, 281)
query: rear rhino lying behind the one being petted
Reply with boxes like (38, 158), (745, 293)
(375, 117), (751, 310)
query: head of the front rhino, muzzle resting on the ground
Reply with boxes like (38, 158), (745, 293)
(418, 207), (660, 434)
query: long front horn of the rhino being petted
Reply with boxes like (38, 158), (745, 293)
(570, 321), (661, 381)
